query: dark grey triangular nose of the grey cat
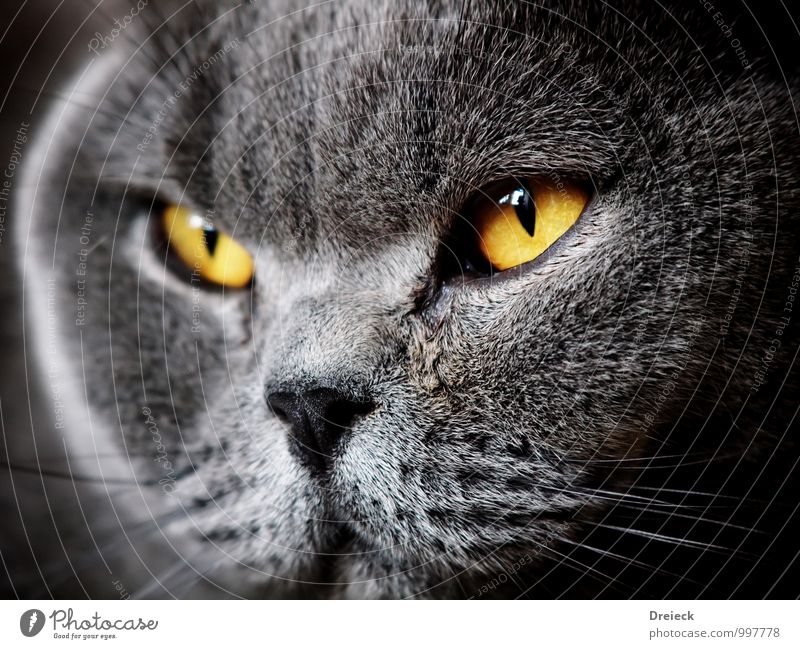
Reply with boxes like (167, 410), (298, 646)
(266, 388), (375, 471)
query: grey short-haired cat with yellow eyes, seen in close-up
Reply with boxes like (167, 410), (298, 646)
(2, 0), (800, 598)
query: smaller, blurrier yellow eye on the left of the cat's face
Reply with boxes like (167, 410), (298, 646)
(161, 205), (254, 288)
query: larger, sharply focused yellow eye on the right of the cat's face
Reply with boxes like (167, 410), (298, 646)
(473, 179), (589, 270)
